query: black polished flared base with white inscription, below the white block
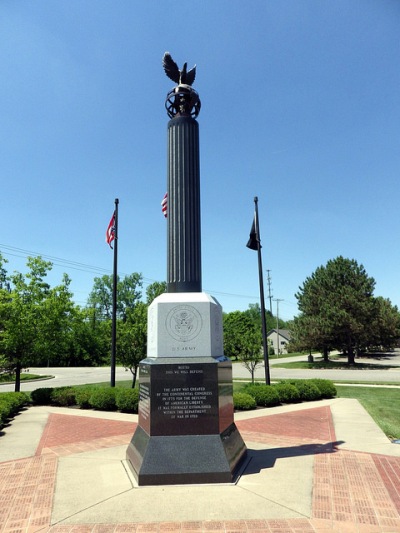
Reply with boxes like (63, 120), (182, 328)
(127, 357), (246, 485)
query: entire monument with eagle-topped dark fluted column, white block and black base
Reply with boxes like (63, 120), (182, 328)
(127, 52), (246, 486)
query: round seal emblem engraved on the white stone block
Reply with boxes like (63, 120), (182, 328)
(165, 305), (202, 342)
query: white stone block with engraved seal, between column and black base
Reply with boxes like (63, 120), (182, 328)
(147, 292), (224, 357)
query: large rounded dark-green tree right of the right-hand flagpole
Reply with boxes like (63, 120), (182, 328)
(295, 256), (375, 364)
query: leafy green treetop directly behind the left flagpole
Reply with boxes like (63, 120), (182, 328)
(88, 272), (142, 321)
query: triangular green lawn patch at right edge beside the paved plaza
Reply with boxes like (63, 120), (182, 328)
(336, 385), (400, 439)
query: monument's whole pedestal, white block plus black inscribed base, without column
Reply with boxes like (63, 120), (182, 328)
(127, 293), (246, 485)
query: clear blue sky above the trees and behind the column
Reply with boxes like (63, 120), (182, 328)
(0, 0), (400, 320)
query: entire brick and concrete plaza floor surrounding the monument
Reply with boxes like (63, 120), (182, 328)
(0, 399), (400, 533)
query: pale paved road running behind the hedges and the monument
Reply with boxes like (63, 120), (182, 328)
(0, 351), (400, 392)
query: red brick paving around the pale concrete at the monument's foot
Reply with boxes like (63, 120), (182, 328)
(0, 407), (400, 533)
